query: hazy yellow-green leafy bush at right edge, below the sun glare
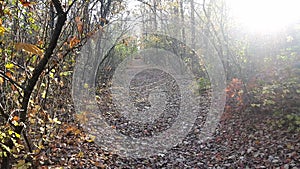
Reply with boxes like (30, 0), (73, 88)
(249, 61), (300, 132)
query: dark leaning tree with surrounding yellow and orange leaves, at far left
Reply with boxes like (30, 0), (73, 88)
(0, 0), (117, 168)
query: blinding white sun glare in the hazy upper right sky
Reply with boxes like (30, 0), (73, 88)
(225, 0), (300, 33)
